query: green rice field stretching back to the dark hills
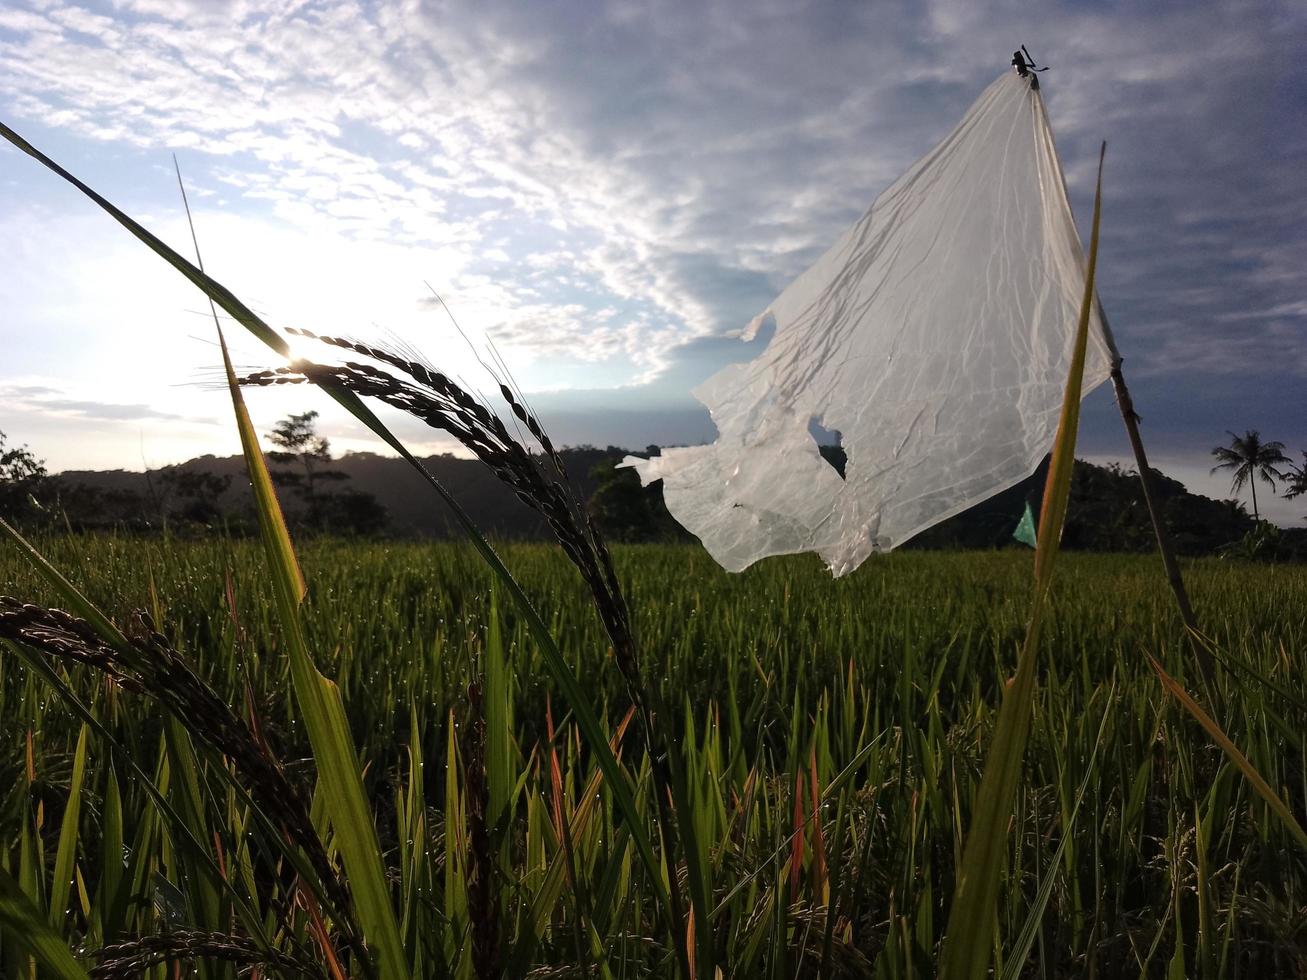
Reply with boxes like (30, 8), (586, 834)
(0, 537), (1307, 979)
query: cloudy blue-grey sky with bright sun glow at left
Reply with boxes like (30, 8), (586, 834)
(0, 0), (1307, 523)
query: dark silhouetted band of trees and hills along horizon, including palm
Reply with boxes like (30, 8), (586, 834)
(0, 423), (1307, 558)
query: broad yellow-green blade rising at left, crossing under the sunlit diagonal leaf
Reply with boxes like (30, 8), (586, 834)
(218, 331), (408, 980)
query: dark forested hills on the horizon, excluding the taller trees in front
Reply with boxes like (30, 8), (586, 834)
(43, 446), (1307, 558)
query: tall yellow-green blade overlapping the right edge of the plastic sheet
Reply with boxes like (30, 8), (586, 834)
(940, 144), (1106, 980)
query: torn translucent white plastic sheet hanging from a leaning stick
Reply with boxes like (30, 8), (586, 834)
(623, 72), (1115, 575)
